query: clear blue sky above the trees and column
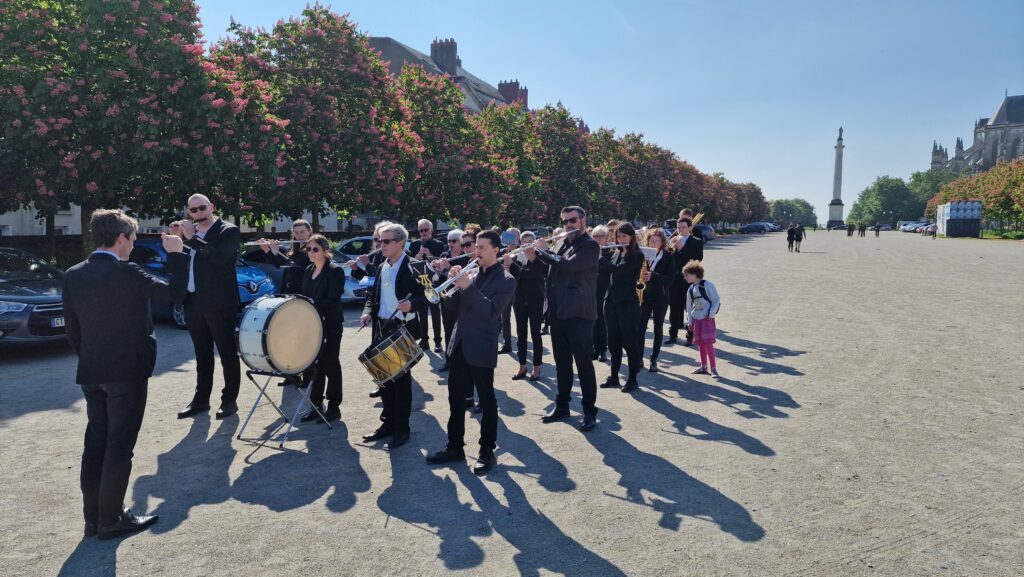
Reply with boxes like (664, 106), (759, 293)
(198, 0), (1024, 221)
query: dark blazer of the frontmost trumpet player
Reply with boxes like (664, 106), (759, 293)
(447, 262), (516, 369)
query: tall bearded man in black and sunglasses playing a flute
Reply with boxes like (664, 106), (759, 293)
(535, 206), (601, 431)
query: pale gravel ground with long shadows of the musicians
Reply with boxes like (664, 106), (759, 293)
(0, 232), (1024, 577)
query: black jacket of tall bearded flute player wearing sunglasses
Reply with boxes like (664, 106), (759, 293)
(537, 233), (601, 321)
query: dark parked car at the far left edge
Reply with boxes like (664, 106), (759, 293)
(0, 247), (67, 344)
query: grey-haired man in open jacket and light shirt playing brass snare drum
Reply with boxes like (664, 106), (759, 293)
(359, 224), (427, 449)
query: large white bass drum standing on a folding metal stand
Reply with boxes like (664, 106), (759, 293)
(236, 295), (324, 375)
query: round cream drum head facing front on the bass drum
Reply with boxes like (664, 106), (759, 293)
(266, 298), (324, 374)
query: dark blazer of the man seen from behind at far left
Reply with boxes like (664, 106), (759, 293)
(62, 253), (188, 384)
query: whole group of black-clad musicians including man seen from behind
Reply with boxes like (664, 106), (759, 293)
(63, 199), (702, 538)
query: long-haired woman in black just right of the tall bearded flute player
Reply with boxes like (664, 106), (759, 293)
(601, 222), (644, 393)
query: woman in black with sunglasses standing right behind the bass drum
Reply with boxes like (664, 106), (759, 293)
(286, 235), (345, 422)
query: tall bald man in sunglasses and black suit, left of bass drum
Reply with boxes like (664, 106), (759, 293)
(171, 195), (242, 419)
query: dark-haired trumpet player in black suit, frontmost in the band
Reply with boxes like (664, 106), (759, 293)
(427, 231), (516, 475)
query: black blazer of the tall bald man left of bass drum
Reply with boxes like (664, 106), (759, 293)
(185, 218), (242, 311)
